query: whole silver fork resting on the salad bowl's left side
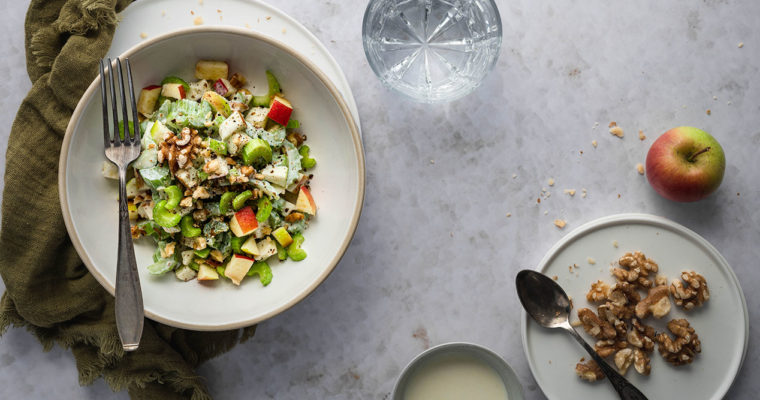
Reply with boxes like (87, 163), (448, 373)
(100, 58), (144, 351)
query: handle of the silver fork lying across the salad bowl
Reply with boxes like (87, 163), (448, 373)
(116, 167), (145, 351)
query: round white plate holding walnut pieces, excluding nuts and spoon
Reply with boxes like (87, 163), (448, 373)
(522, 214), (749, 400)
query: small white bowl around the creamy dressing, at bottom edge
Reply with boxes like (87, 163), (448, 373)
(391, 342), (523, 400)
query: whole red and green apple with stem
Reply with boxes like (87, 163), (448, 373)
(646, 126), (726, 202)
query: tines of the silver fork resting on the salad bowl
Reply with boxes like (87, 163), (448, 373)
(100, 58), (140, 148)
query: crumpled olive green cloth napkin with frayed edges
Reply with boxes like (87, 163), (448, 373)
(0, 0), (255, 400)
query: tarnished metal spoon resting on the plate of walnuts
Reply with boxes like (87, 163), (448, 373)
(516, 269), (647, 400)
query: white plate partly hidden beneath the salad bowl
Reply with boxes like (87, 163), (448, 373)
(108, 0), (361, 130)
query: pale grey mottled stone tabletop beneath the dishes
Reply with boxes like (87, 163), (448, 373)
(0, 0), (760, 399)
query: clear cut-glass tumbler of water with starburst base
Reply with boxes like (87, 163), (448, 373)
(362, 0), (502, 103)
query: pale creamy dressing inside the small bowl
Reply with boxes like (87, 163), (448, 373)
(403, 354), (508, 400)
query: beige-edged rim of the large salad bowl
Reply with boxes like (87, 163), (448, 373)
(58, 26), (366, 331)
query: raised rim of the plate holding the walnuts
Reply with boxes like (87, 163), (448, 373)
(520, 213), (750, 399)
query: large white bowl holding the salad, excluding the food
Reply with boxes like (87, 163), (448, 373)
(58, 27), (364, 330)
